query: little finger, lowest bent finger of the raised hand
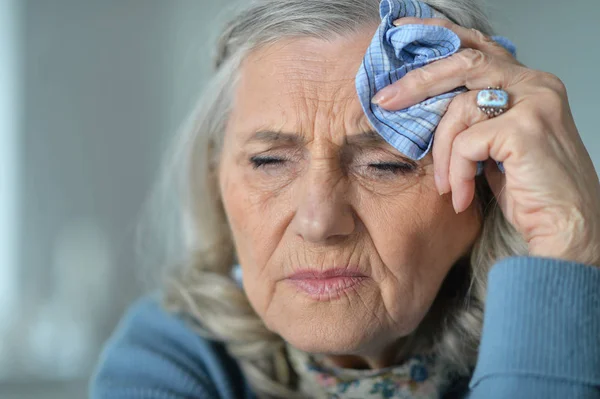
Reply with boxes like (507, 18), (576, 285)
(449, 114), (515, 213)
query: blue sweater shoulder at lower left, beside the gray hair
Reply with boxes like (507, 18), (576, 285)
(90, 297), (250, 399)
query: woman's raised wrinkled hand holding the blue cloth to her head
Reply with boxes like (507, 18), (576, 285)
(374, 18), (600, 266)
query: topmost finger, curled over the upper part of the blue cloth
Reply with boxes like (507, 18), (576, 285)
(393, 17), (518, 59)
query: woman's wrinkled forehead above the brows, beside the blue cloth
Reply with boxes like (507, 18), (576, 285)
(230, 27), (377, 141)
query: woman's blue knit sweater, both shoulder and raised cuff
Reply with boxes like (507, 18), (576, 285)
(90, 257), (600, 399)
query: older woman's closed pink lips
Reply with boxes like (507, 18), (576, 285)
(287, 268), (368, 301)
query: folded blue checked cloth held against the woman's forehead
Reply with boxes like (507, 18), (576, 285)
(356, 0), (515, 160)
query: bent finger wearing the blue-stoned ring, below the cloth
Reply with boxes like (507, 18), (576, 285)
(432, 91), (488, 195)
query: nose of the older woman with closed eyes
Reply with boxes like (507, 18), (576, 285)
(292, 160), (356, 243)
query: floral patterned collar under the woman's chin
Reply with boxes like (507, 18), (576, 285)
(287, 345), (443, 399)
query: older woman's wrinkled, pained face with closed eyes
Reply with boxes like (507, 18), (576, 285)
(219, 29), (480, 355)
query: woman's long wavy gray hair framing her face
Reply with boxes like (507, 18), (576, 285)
(149, 0), (526, 398)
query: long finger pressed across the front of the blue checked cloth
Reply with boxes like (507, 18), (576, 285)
(373, 48), (530, 111)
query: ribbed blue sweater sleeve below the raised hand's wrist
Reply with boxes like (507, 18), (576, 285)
(467, 257), (600, 399)
